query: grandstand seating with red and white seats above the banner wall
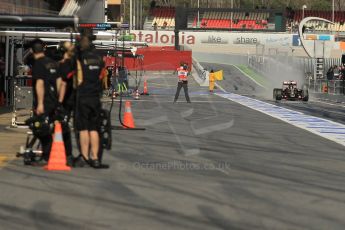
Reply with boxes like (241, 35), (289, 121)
(144, 7), (345, 33)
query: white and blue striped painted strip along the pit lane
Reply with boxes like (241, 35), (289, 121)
(216, 93), (345, 146)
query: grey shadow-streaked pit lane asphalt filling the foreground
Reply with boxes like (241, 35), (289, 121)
(0, 75), (345, 230)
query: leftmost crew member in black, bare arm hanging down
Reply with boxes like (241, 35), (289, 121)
(31, 39), (58, 161)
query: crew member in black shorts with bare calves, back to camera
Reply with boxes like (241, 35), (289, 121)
(75, 32), (104, 168)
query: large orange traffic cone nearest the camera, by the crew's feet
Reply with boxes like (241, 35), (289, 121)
(44, 122), (71, 171)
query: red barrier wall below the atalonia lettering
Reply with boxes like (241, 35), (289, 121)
(106, 46), (192, 71)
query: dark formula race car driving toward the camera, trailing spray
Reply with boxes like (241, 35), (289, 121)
(273, 81), (309, 101)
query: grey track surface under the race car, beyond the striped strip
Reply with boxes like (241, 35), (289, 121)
(201, 63), (345, 124)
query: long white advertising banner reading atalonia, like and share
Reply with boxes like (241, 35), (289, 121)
(127, 30), (344, 54)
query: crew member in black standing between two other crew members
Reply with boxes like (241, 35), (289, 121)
(58, 42), (75, 166)
